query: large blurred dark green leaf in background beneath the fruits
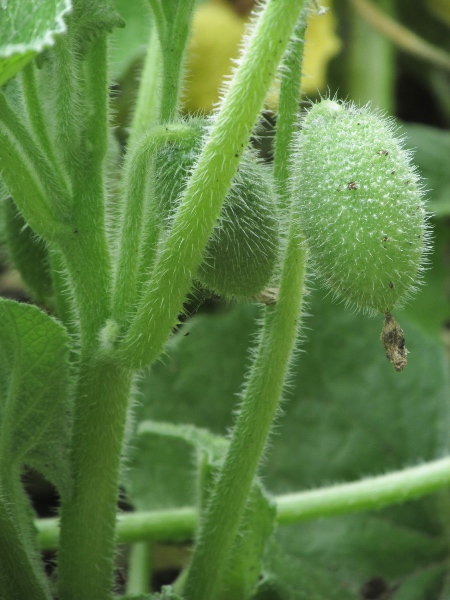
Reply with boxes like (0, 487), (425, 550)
(141, 293), (450, 600)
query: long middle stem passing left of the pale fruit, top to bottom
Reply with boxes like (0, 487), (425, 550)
(184, 9), (308, 600)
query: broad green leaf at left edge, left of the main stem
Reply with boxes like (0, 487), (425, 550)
(0, 299), (70, 495)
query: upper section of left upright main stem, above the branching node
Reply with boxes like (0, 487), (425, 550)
(59, 37), (112, 352)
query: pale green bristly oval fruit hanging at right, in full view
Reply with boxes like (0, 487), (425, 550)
(294, 100), (429, 313)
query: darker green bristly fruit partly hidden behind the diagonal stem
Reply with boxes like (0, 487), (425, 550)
(154, 119), (279, 298)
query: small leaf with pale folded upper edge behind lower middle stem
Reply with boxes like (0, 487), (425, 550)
(127, 421), (275, 600)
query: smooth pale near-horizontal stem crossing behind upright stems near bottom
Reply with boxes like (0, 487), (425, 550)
(36, 457), (450, 550)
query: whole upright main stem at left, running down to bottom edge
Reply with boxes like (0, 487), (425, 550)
(58, 36), (125, 600)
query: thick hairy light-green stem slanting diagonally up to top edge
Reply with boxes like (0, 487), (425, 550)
(122, 0), (303, 367)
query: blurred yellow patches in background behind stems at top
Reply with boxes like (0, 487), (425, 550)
(183, 0), (341, 112)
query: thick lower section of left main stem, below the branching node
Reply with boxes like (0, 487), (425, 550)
(58, 358), (131, 600)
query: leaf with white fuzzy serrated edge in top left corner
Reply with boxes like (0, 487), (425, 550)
(0, 0), (72, 85)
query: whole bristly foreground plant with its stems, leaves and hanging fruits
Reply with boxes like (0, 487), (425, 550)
(0, 0), (443, 600)
